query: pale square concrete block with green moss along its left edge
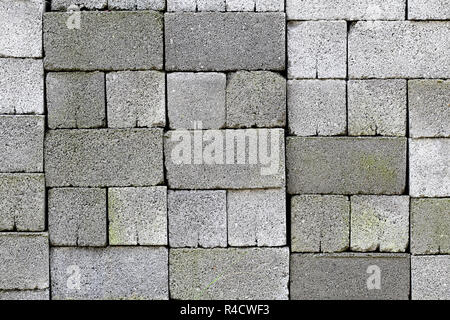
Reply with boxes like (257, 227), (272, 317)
(108, 187), (167, 246)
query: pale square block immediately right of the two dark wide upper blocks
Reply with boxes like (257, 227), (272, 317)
(287, 21), (347, 79)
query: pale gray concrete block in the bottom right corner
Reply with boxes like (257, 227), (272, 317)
(411, 256), (450, 300)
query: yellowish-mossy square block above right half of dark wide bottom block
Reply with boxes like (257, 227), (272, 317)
(350, 196), (409, 252)
